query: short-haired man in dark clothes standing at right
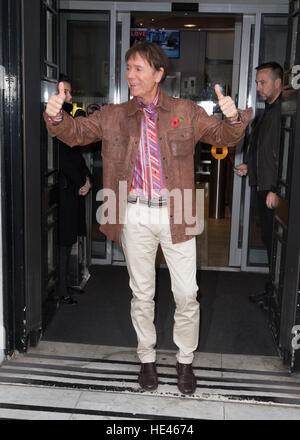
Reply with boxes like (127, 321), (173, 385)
(235, 62), (283, 308)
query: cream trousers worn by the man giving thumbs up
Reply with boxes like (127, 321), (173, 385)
(121, 201), (200, 364)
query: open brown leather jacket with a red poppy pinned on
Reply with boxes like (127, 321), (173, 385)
(44, 91), (252, 243)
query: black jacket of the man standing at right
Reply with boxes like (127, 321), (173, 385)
(245, 95), (282, 192)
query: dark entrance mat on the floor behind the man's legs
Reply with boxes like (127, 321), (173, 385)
(43, 266), (277, 356)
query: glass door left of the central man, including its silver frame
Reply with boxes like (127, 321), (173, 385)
(60, 6), (130, 264)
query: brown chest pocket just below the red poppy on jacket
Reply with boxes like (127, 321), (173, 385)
(167, 127), (195, 157)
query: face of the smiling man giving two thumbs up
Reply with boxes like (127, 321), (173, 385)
(126, 53), (163, 104)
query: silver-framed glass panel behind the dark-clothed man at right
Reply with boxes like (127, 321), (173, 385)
(229, 13), (288, 273)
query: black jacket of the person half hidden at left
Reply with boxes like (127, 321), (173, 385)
(58, 103), (91, 246)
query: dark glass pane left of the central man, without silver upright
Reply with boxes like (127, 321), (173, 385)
(60, 10), (111, 268)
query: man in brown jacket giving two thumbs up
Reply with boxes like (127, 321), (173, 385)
(44, 41), (252, 394)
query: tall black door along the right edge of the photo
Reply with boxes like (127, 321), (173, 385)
(269, 0), (300, 372)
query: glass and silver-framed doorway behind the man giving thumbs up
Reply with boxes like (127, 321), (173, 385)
(61, 6), (287, 273)
